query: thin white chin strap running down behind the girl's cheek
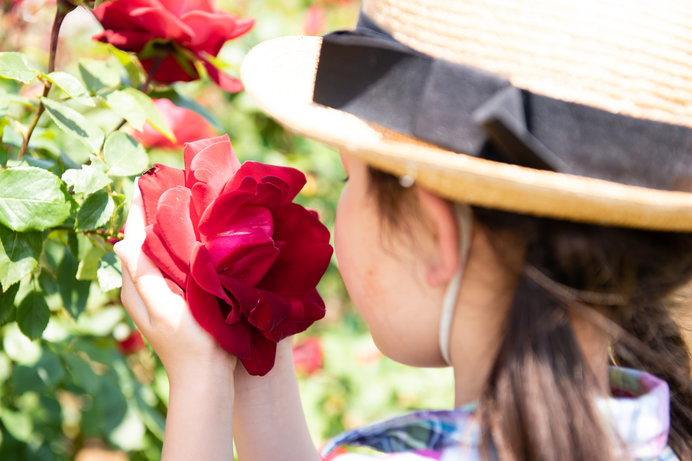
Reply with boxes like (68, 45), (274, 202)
(440, 204), (473, 365)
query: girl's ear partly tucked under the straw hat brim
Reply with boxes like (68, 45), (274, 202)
(415, 186), (460, 286)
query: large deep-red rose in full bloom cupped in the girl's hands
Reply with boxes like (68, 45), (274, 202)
(139, 136), (332, 375)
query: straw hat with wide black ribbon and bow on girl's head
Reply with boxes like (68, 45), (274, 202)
(241, 0), (692, 231)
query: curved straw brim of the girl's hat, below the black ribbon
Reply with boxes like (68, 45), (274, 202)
(241, 36), (692, 231)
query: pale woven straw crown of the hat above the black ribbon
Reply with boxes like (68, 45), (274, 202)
(363, 0), (692, 127)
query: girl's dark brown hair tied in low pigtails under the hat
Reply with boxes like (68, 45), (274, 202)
(370, 169), (692, 460)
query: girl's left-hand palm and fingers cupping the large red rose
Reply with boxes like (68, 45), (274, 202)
(114, 183), (237, 380)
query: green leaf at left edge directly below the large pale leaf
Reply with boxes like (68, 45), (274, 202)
(0, 226), (43, 290)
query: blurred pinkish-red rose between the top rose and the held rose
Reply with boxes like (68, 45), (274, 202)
(133, 99), (216, 147)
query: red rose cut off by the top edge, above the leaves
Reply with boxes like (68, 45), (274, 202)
(94, 0), (254, 92)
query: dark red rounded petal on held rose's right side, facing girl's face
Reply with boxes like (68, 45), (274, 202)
(257, 203), (332, 296)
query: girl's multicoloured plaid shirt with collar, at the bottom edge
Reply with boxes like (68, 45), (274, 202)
(322, 367), (678, 461)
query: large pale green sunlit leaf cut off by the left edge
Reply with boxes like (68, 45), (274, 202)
(0, 167), (71, 231)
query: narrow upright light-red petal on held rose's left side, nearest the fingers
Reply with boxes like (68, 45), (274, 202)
(154, 186), (197, 266)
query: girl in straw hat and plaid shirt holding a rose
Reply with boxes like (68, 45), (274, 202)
(116, 0), (692, 461)
